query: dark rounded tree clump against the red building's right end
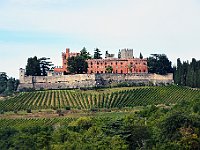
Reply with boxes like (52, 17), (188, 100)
(147, 54), (173, 75)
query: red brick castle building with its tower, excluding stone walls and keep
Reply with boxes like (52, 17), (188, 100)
(54, 48), (148, 74)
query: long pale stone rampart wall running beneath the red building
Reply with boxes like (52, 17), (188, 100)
(18, 73), (173, 90)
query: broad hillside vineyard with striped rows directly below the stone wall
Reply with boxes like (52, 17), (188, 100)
(0, 86), (200, 111)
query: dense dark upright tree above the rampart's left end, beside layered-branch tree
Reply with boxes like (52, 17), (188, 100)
(26, 56), (41, 76)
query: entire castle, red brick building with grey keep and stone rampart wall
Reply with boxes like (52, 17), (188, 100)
(18, 48), (173, 90)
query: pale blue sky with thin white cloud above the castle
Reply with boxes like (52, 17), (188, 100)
(0, 0), (200, 78)
